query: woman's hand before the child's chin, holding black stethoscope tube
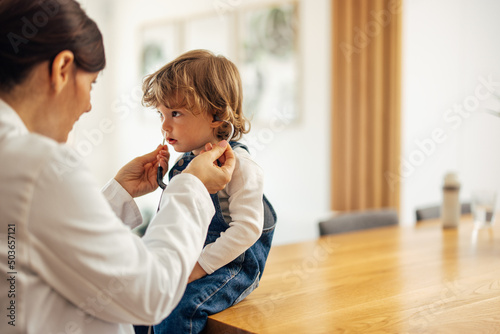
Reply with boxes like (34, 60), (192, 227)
(115, 145), (170, 197)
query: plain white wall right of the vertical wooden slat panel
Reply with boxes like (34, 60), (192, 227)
(401, 0), (500, 224)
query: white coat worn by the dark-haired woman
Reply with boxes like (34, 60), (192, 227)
(0, 100), (214, 334)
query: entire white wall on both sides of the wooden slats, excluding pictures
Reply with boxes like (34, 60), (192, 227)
(74, 0), (500, 243)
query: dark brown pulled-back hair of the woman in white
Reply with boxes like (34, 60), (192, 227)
(0, 0), (106, 92)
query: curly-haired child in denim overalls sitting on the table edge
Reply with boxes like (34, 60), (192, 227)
(139, 50), (276, 333)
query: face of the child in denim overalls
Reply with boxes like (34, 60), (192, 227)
(158, 106), (217, 154)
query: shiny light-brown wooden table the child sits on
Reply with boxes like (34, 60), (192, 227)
(206, 217), (500, 334)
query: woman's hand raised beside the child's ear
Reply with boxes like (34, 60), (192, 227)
(183, 140), (236, 194)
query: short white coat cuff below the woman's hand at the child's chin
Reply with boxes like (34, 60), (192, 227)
(101, 179), (142, 229)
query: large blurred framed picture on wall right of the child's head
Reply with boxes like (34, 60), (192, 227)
(237, 2), (300, 123)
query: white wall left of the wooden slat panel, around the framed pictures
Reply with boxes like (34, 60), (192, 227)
(77, 0), (330, 244)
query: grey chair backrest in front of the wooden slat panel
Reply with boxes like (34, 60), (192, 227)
(319, 209), (399, 235)
